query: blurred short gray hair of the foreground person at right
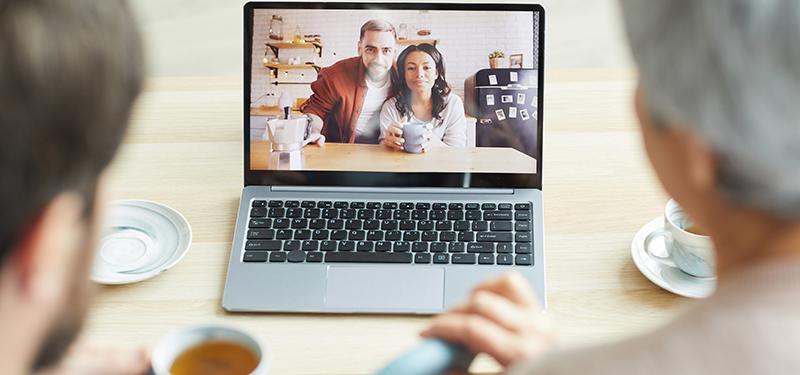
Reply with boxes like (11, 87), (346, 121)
(621, 0), (800, 218)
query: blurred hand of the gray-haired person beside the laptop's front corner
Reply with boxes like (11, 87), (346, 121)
(421, 273), (555, 367)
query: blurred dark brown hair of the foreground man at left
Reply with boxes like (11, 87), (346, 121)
(0, 0), (143, 268)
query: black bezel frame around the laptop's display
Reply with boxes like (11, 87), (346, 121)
(243, 1), (545, 190)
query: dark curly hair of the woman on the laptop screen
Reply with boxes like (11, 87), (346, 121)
(392, 43), (450, 119)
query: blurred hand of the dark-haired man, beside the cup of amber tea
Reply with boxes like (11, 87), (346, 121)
(36, 340), (150, 375)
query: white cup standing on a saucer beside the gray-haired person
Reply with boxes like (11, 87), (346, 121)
(644, 199), (716, 278)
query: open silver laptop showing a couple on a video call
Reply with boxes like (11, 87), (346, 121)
(222, 2), (546, 314)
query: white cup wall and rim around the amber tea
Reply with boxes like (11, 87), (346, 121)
(151, 324), (272, 375)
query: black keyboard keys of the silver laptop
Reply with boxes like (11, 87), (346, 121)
(243, 200), (533, 266)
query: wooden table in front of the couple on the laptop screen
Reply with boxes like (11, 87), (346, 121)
(250, 141), (536, 173)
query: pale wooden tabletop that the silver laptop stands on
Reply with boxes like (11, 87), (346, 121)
(86, 70), (688, 374)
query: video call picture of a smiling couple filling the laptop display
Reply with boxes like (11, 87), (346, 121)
(250, 9), (539, 174)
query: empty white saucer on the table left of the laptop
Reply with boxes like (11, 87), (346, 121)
(91, 200), (192, 284)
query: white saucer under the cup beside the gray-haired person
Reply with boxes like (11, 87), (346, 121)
(631, 217), (717, 298)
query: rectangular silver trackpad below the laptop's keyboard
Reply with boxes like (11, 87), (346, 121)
(325, 266), (444, 311)
